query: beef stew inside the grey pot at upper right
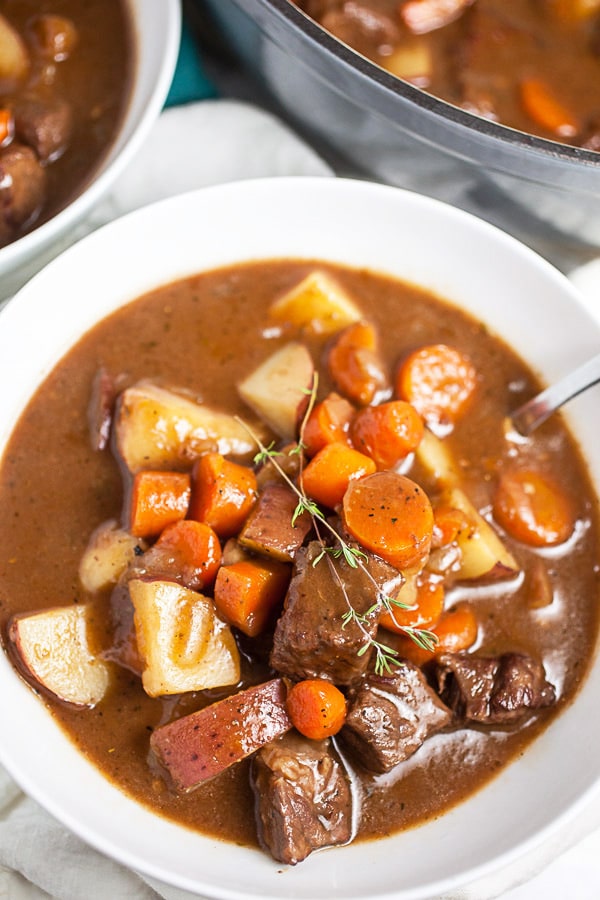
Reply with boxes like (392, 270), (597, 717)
(293, 0), (600, 150)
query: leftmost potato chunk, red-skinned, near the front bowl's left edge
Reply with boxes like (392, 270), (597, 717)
(9, 604), (110, 707)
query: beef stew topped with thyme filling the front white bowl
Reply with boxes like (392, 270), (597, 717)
(0, 261), (598, 863)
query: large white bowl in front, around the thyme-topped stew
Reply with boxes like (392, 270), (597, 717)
(0, 178), (600, 900)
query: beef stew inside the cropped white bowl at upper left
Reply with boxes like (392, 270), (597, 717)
(0, 0), (135, 246)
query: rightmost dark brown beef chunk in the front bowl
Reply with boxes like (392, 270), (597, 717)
(436, 653), (556, 725)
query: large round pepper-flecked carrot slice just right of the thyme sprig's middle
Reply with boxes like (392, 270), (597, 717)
(343, 471), (433, 569)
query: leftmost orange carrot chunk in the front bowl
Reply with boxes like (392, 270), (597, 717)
(129, 471), (191, 538)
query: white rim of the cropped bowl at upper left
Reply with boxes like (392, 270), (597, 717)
(0, 0), (182, 274)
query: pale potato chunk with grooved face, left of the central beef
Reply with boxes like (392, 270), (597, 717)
(129, 579), (240, 697)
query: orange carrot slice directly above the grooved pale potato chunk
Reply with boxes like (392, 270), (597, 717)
(150, 519), (222, 589)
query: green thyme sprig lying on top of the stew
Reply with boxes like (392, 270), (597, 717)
(239, 372), (437, 675)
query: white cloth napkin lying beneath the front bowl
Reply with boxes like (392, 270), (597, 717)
(0, 100), (600, 900)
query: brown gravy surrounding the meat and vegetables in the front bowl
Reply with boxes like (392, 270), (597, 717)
(0, 261), (599, 845)
